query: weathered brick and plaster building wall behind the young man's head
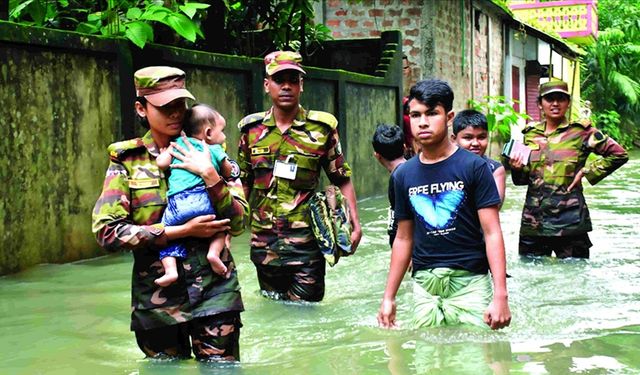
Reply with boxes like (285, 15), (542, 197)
(323, 0), (503, 110)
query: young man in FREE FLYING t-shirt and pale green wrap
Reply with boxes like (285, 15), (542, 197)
(378, 80), (511, 329)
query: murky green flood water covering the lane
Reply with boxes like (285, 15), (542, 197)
(0, 152), (640, 375)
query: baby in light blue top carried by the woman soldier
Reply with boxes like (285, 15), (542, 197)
(155, 104), (238, 287)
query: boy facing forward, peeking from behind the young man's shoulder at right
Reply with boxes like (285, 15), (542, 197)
(451, 109), (507, 206)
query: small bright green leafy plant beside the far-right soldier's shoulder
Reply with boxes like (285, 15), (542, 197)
(468, 96), (530, 141)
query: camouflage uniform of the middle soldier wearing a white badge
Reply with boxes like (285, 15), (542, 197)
(238, 107), (351, 300)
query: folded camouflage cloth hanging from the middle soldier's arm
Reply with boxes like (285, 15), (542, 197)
(309, 185), (352, 267)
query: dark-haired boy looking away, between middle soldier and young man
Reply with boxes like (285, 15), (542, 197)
(371, 124), (406, 246)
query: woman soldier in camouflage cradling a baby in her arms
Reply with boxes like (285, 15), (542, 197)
(93, 67), (248, 360)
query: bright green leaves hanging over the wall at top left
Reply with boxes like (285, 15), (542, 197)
(9, 0), (209, 48)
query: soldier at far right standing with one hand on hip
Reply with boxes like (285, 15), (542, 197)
(510, 81), (628, 258)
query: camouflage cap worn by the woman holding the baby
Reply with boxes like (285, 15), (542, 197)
(133, 66), (196, 107)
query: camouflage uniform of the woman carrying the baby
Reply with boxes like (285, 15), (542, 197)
(93, 132), (248, 359)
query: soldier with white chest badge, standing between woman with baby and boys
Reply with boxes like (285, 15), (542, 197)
(238, 51), (362, 301)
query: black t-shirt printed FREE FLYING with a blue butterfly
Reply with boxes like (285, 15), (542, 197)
(394, 148), (500, 274)
